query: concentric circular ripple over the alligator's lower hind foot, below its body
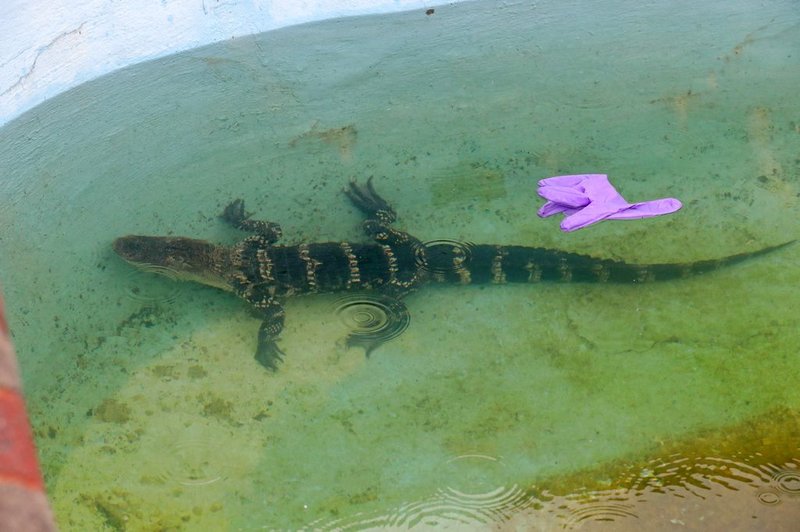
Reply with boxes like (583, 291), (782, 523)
(336, 294), (411, 346)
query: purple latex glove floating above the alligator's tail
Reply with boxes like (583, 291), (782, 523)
(538, 174), (682, 231)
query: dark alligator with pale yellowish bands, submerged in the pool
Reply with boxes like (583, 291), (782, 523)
(113, 178), (794, 371)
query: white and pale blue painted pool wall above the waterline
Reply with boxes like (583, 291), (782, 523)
(0, 0), (464, 125)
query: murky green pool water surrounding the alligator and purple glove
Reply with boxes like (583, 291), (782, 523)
(0, 1), (800, 530)
